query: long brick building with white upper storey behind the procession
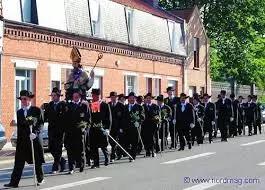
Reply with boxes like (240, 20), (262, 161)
(0, 0), (210, 137)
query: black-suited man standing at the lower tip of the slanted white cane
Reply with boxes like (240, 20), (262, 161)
(125, 92), (145, 161)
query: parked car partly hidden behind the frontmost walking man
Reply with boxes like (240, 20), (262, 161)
(10, 122), (49, 151)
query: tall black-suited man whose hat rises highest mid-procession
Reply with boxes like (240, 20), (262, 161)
(164, 87), (179, 148)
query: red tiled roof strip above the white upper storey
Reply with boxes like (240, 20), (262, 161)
(112, 0), (181, 21)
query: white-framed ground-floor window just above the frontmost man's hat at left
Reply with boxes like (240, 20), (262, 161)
(15, 69), (34, 110)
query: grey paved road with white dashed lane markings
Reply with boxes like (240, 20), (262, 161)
(0, 134), (265, 190)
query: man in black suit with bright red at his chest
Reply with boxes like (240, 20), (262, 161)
(89, 89), (112, 169)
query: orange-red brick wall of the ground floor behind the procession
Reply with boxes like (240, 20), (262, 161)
(1, 36), (182, 137)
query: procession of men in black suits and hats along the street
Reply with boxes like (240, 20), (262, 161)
(5, 87), (262, 187)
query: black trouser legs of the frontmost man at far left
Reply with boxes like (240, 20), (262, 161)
(10, 158), (44, 185)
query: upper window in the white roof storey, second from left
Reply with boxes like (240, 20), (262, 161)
(89, 0), (103, 37)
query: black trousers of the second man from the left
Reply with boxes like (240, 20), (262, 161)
(49, 130), (65, 171)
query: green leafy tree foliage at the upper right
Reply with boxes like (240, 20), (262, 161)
(160, 0), (265, 85)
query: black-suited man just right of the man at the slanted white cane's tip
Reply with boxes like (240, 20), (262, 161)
(142, 93), (160, 157)
